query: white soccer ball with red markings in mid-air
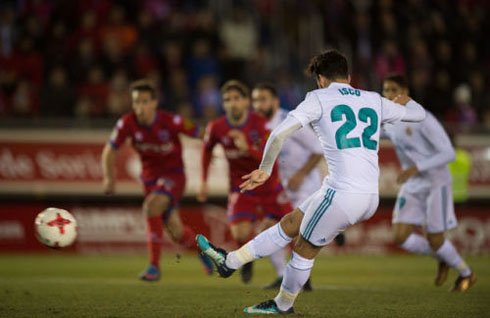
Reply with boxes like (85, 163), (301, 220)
(34, 208), (77, 249)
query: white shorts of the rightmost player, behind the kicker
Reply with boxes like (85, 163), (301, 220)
(392, 184), (458, 233)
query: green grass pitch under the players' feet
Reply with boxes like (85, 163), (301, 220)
(0, 252), (490, 318)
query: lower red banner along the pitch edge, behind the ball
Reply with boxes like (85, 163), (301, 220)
(0, 204), (490, 254)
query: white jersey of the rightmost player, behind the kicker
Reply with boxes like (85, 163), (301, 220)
(382, 112), (455, 193)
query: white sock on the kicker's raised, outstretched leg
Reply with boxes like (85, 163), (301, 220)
(226, 223), (293, 269)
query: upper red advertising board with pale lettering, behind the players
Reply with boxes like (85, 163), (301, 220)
(0, 130), (490, 198)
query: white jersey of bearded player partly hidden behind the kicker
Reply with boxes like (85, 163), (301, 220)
(267, 108), (322, 200)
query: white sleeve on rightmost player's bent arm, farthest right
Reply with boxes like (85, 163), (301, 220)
(416, 115), (456, 171)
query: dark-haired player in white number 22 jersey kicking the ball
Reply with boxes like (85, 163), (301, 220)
(196, 50), (425, 314)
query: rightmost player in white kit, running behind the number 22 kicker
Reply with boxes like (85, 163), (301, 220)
(382, 75), (476, 291)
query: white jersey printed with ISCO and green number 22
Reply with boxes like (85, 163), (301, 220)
(289, 83), (415, 193)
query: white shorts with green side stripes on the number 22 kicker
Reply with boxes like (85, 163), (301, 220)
(299, 185), (379, 246)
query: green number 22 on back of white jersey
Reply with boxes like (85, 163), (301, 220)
(330, 104), (378, 150)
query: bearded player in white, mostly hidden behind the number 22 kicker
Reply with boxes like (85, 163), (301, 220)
(252, 83), (323, 291)
